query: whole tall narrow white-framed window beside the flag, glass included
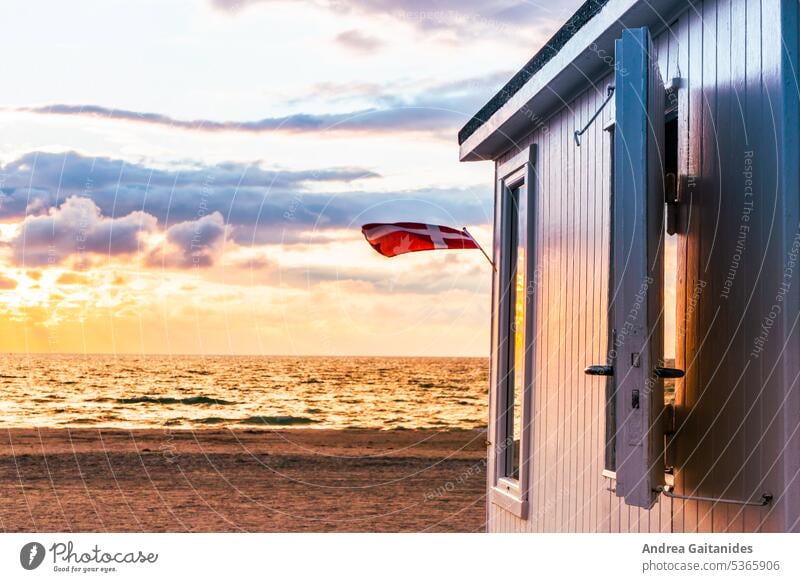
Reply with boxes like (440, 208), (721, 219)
(490, 146), (535, 518)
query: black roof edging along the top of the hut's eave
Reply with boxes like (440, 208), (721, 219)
(458, 0), (609, 145)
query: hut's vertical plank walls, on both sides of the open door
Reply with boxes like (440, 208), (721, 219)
(488, 0), (800, 532)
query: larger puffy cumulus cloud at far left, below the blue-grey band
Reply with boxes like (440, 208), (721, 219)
(9, 196), (157, 266)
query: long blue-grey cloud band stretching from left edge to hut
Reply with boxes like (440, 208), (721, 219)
(0, 152), (492, 242)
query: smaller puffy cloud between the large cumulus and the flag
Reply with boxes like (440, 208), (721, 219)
(146, 212), (225, 269)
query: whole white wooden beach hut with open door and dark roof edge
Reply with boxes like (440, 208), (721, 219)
(458, 0), (800, 532)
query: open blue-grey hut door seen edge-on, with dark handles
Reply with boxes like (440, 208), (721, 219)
(610, 28), (665, 508)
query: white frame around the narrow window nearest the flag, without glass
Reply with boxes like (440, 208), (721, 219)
(489, 145), (536, 519)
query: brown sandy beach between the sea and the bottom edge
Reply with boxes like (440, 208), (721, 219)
(0, 428), (486, 532)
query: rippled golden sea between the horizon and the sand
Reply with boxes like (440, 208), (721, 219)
(0, 354), (489, 430)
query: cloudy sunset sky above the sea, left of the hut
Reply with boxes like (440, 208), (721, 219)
(0, 0), (580, 356)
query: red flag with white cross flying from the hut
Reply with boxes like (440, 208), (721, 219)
(361, 222), (482, 257)
